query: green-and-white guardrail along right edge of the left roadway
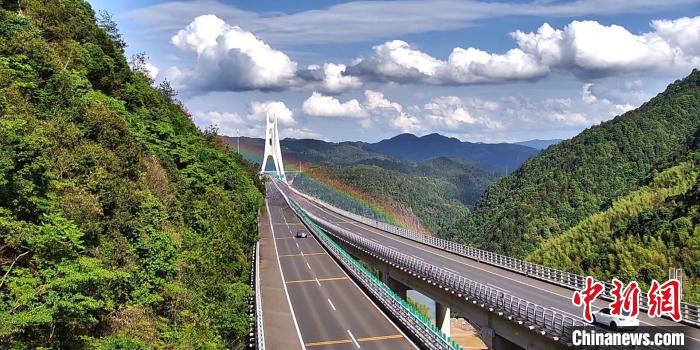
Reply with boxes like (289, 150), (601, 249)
(275, 180), (461, 350)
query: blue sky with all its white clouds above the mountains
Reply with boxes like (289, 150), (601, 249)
(90, 0), (700, 142)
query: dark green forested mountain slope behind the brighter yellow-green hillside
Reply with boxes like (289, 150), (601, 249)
(471, 70), (700, 258)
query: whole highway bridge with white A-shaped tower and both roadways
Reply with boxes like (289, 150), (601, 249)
(252, 113), (700, 350)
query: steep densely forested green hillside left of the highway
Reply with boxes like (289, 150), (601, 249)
(0, 0), (262, 349)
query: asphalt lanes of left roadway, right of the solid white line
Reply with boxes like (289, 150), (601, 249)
(263, 186), (416, 350)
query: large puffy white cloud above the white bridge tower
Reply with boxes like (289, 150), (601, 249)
(171, 15), (297, 91)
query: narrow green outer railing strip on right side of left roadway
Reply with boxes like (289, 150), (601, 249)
(290, 197), (462, 350)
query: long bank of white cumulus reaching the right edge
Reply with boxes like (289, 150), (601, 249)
(346, 16), (700, 85)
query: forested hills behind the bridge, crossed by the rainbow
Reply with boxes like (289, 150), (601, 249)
(232, 135), (500, 238)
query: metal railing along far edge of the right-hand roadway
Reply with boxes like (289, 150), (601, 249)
(289, 186), (700, 326)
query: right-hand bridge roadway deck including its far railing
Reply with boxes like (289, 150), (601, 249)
(288, 186), (700, 349)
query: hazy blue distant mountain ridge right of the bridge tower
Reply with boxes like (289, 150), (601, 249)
(367, 134), (539, 173)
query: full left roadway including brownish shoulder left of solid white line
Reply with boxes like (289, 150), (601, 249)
(260, 186), (415, 349)
